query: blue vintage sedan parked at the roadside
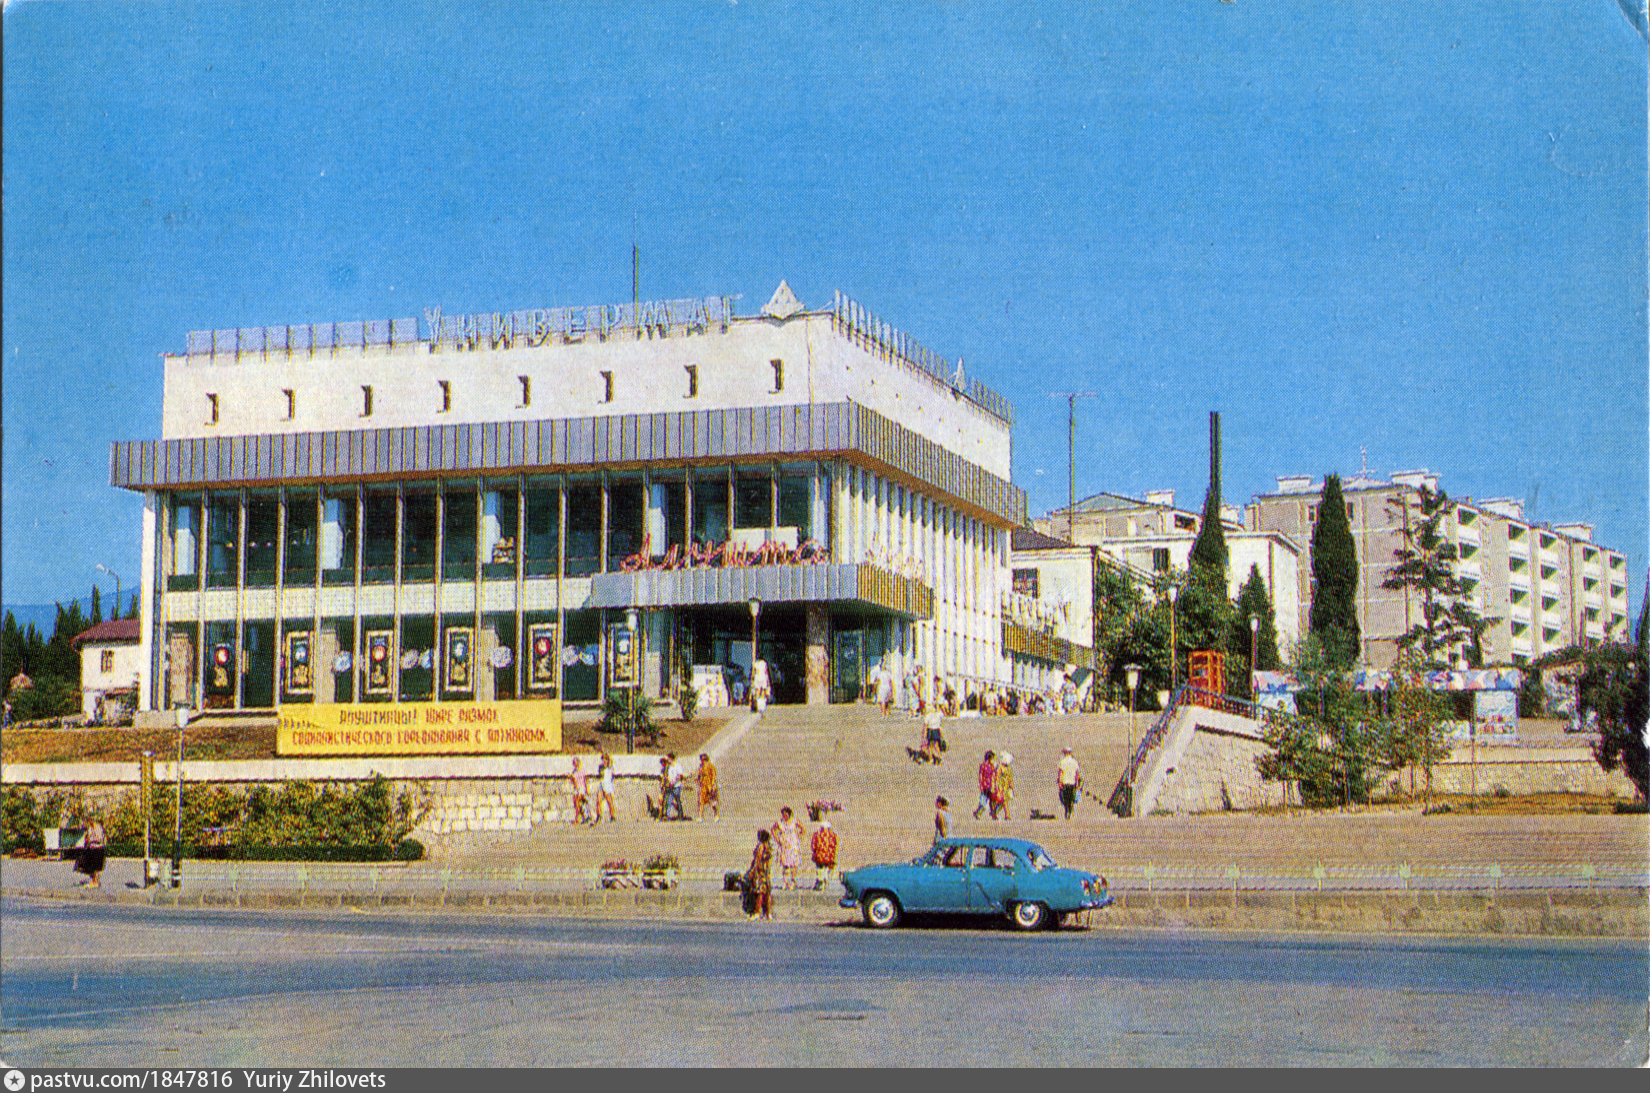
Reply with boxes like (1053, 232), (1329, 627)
(840, 837), (1112, 930)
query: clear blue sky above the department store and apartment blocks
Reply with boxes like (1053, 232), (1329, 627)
(3, 0), (1650, 624)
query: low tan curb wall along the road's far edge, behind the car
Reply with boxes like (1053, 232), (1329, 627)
(8, 888), (1650, 939)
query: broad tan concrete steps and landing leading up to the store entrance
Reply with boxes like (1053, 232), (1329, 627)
(442, 707), (1643, 875)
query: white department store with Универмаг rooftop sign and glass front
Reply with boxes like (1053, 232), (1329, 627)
(112, 284), (1056, 710)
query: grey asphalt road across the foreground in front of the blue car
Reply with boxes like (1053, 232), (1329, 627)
(0, 898), (1650, 1067)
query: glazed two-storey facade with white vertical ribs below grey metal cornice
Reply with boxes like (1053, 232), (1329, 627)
(158, 462), (1010, 708)
